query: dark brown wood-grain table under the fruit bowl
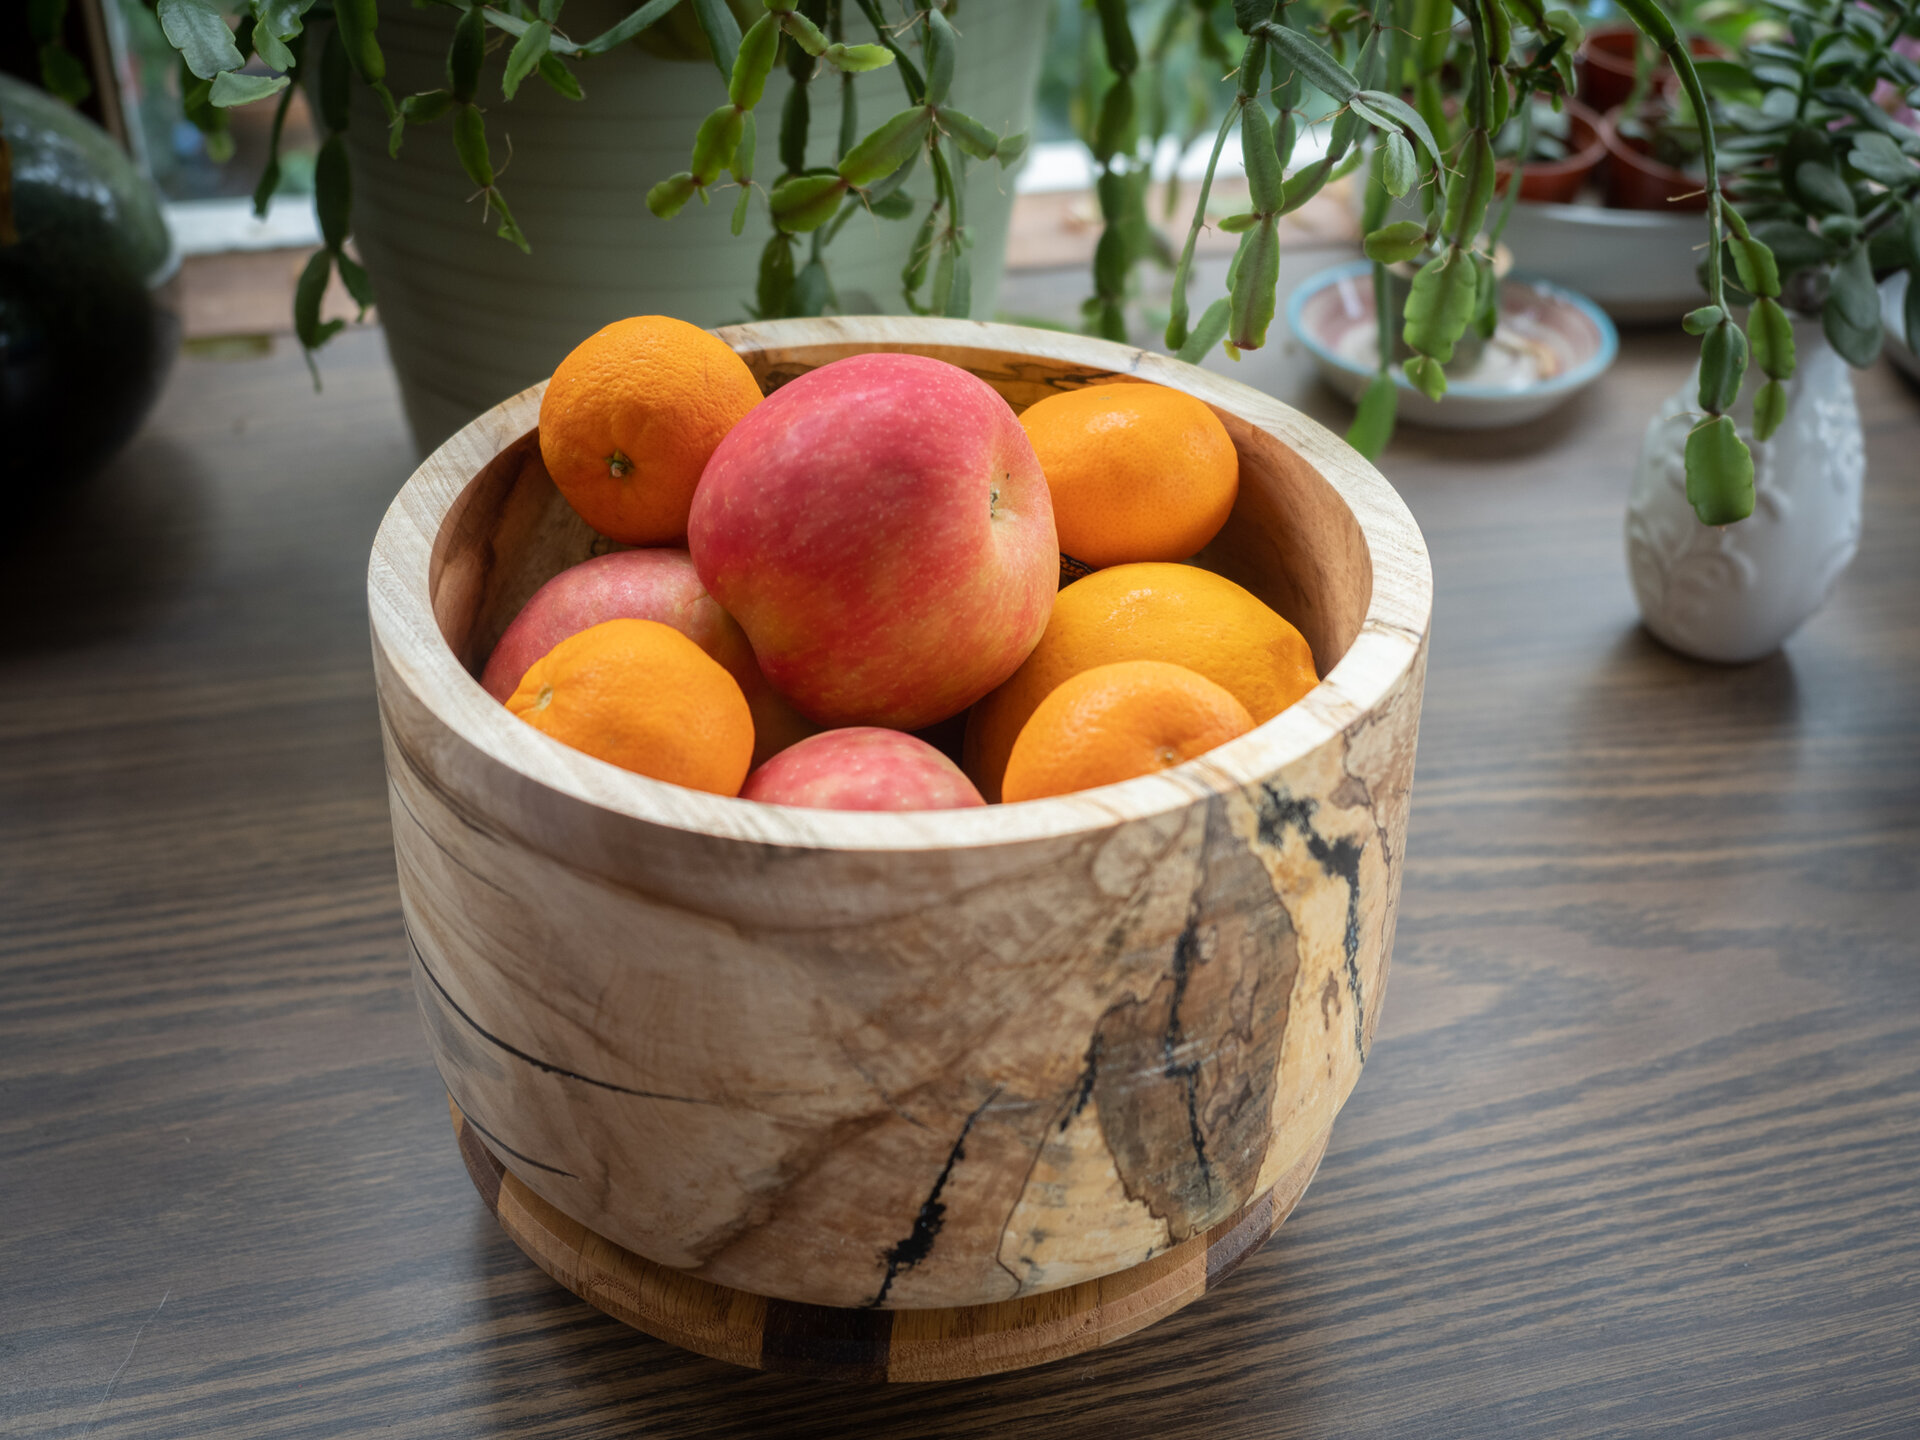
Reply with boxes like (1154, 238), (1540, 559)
(0, 311), (1920, 1440)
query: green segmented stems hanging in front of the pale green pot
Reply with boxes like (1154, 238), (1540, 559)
(33, 0), (1025, 372)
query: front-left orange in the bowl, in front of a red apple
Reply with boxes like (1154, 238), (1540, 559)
(507, 620), (753, 795)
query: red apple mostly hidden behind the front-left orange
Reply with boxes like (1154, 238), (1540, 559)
(480, 549), (814, 762)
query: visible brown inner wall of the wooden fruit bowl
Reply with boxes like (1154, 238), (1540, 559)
(428, 330), (1373, 721)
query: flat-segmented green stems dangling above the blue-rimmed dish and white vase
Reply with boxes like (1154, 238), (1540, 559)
(1067, 0), (1791, 524)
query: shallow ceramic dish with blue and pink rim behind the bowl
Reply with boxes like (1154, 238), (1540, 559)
(1286, 259), (1620, 430)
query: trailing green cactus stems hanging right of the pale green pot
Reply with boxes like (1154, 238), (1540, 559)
(1021, 0), (1766, 524)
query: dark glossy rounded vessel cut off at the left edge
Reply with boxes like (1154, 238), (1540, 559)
(0, 75), (180, 503)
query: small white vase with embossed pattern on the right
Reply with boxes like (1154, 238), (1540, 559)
(1626, 317), (1866, 664)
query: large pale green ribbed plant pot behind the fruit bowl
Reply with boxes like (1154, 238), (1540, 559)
(348, 0), (1048, 451)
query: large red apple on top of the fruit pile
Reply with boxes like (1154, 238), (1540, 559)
(687, 355), (1060, 730)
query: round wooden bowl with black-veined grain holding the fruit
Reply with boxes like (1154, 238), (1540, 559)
(369, 317), (1432, 1369)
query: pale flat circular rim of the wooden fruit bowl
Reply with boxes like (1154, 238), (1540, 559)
(367, 315), (1432, 852)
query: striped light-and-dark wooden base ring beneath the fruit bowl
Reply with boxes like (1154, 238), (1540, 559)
(447, 1098), (1331, 1380)
